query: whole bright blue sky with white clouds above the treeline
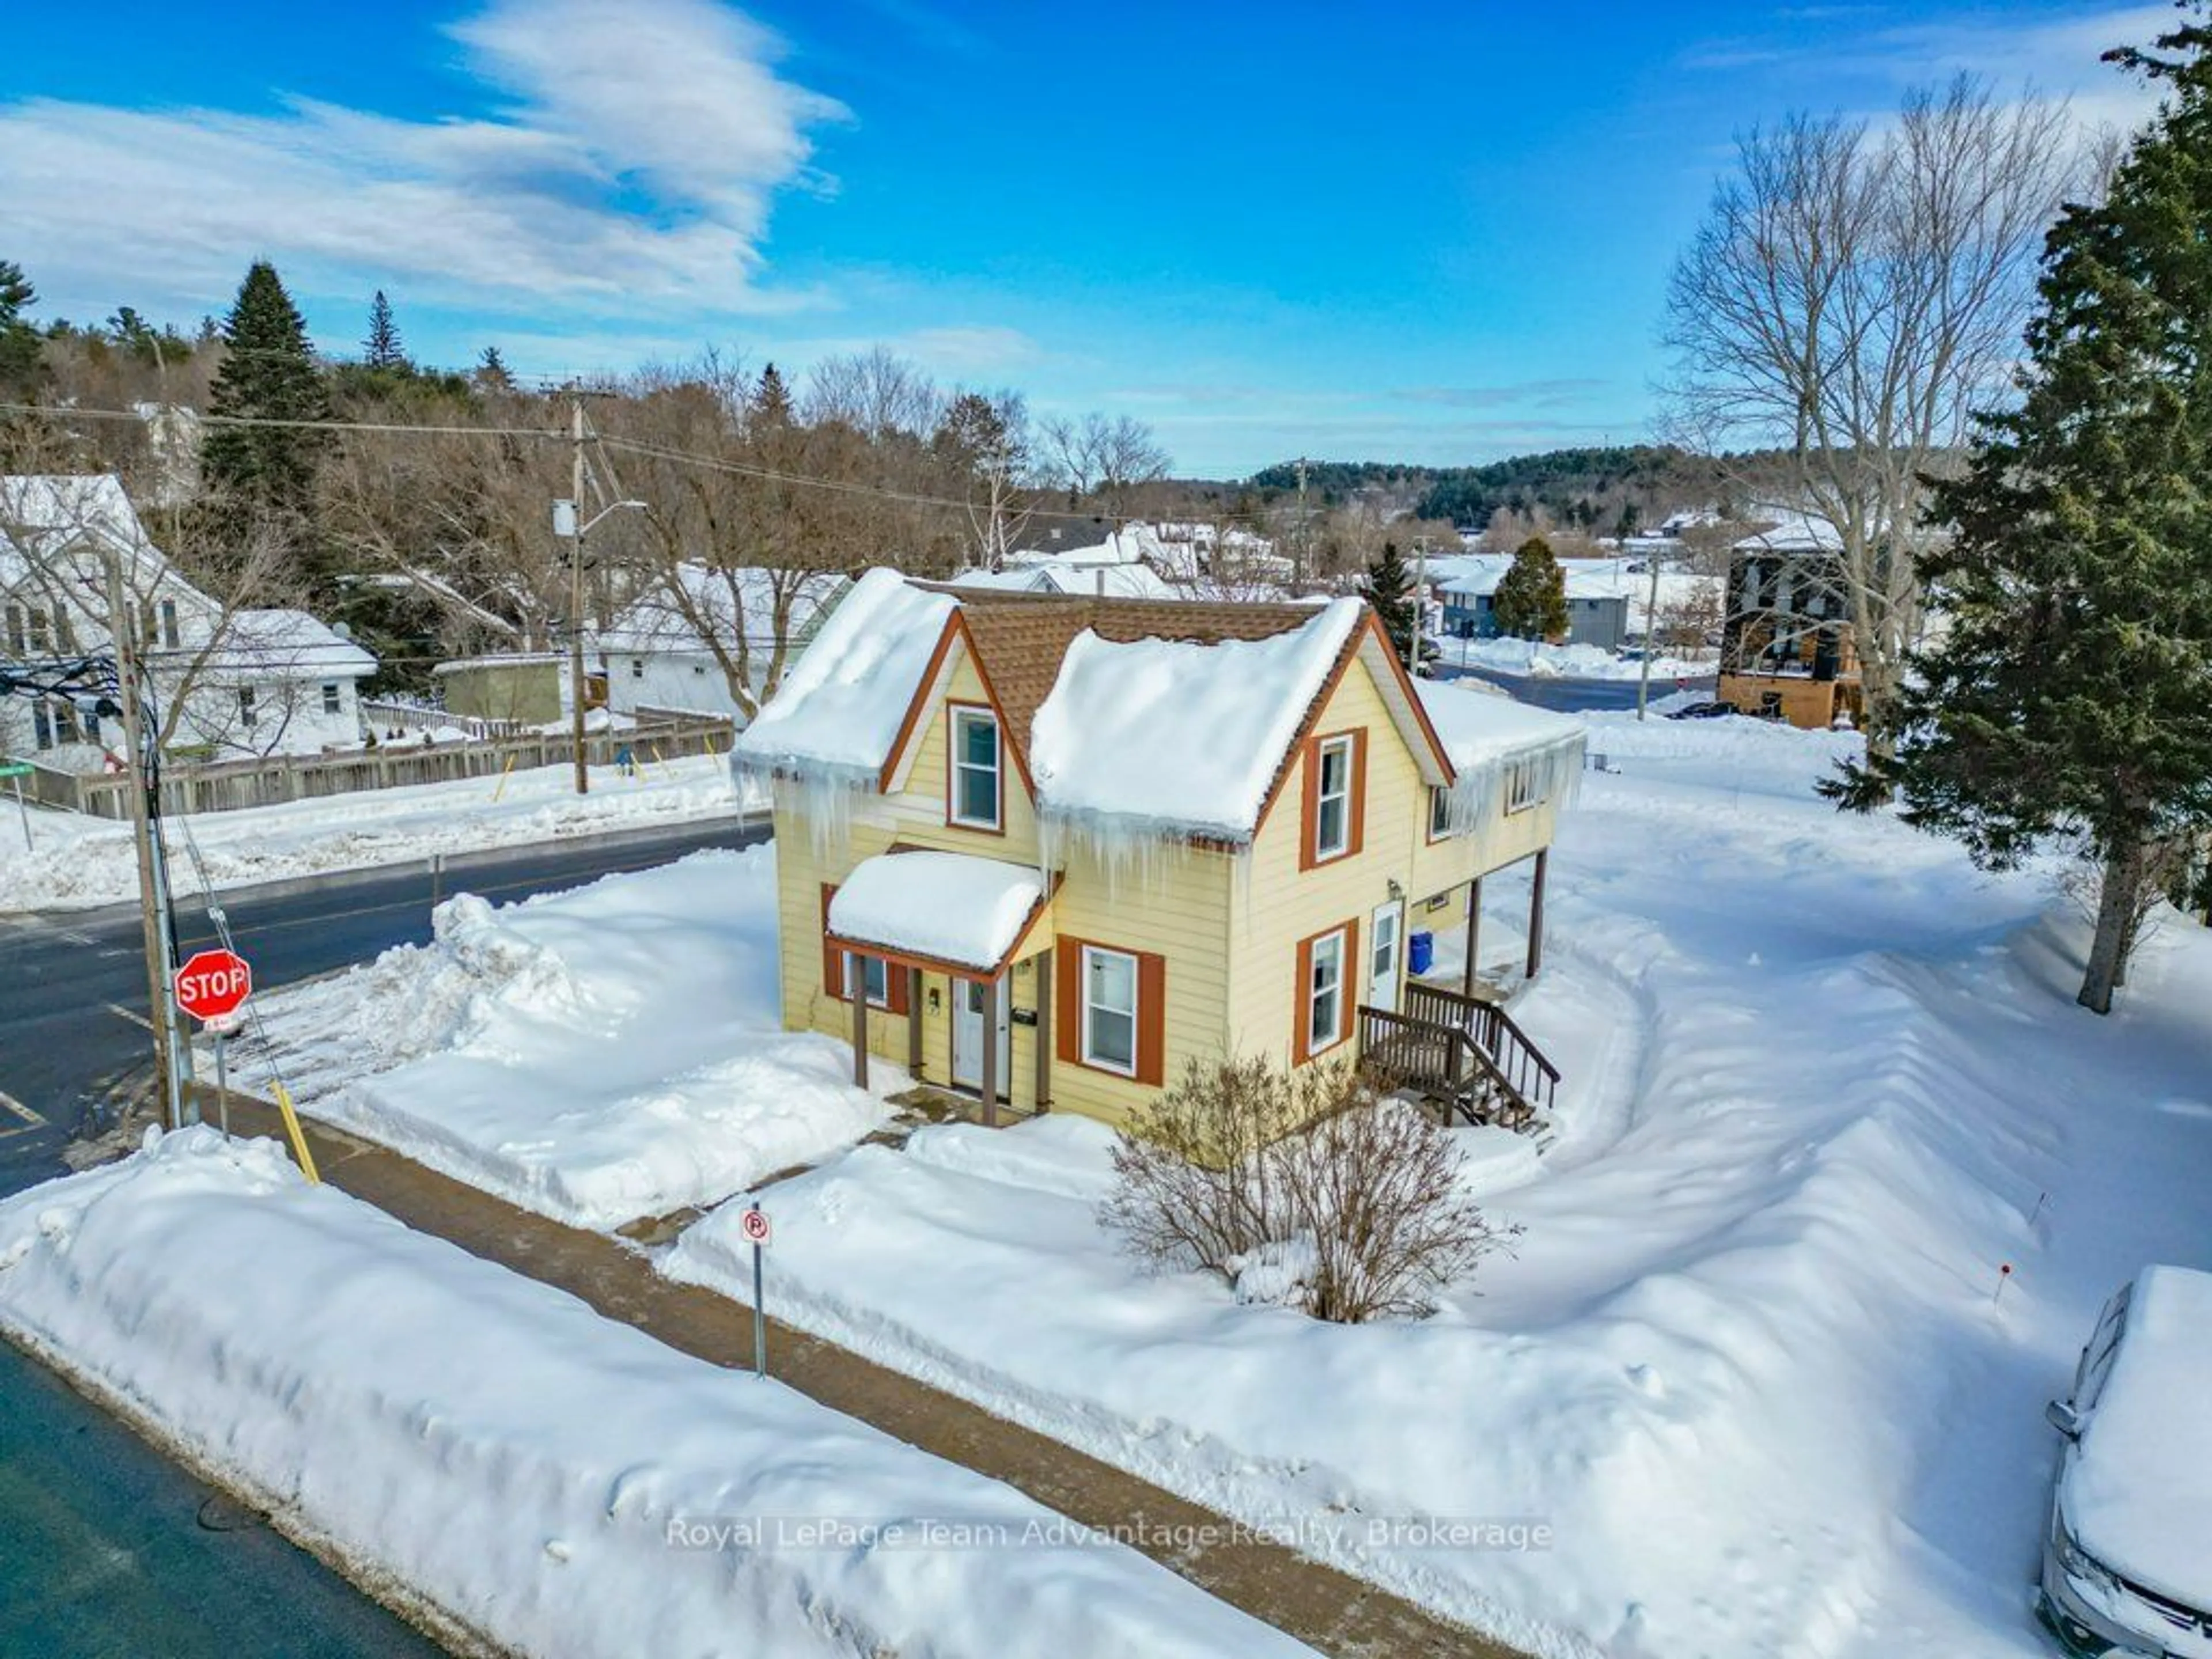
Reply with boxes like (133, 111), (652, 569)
(0, 0), (2172, 476)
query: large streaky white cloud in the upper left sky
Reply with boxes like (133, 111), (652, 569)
(0, 0), (845, 327)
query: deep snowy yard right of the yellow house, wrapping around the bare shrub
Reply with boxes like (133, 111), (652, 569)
(646, 719), (2212, 1654)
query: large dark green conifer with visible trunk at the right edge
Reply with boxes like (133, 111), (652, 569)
(1827, 5), (2212, 1013)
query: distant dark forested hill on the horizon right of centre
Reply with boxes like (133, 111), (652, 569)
(1248, 445), (1796, 531)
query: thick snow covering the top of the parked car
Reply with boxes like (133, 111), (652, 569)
(2062, 1267), (2212, 1606)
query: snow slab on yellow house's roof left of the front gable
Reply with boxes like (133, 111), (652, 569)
(732, 571), (956, 785)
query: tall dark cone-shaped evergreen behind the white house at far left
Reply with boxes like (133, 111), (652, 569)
(201, 261), (329, 520)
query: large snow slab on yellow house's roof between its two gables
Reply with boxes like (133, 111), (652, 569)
(1029, 600), (1362, 840)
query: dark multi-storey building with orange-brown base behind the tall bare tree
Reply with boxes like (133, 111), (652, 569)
(1717, 511), (1865, 730)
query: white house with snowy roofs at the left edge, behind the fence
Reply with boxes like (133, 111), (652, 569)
(0, 476), (376, 770)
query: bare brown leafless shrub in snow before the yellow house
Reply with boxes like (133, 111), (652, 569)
(1099, 1059), (1520, 1325)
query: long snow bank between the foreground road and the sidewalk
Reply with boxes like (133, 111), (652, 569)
(0, 1128), (1305, 1659)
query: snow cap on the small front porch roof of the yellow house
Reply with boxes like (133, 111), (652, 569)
(830, 851), (1044, 971)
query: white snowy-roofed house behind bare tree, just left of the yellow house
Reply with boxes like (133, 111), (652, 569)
(593, 564), (851, 726)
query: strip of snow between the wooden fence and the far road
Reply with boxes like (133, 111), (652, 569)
(0, 752), (766, 911)
